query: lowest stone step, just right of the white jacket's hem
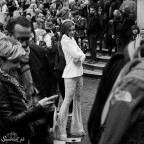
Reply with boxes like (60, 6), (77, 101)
(84, 69), (102, 79)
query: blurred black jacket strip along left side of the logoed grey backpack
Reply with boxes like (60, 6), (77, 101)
(88, 53), (126, 144)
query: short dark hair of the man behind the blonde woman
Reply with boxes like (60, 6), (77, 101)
(6, 16), (31, 34)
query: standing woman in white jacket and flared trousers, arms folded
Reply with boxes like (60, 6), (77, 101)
(55, 20), (85, 140)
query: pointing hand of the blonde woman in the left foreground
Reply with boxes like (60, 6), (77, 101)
(38, 95), (58, 113)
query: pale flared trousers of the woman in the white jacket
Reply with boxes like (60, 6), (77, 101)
(58, 76), (84, 135)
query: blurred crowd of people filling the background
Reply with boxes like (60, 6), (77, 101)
(0, 0), (139, 63)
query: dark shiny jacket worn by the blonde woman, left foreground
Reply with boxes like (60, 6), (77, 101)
(0, 75), (44, 143)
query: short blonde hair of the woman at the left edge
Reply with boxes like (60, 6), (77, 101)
(0, 36), (26, 60)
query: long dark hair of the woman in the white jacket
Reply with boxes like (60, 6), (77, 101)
(59, 21), (74, 41)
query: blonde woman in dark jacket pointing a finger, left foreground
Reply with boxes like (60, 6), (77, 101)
(0, 36), (56, 144)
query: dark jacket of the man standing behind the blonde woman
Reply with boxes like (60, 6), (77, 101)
(29, 44), (53, 98)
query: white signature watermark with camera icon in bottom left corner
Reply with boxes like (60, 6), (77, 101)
(1, 132), (30, 144)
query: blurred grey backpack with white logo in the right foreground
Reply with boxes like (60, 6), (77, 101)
(93, 59), (144, 144)
